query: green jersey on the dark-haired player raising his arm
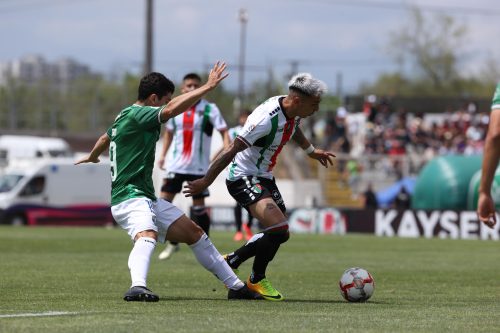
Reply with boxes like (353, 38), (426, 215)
(107, 104), (162, 206)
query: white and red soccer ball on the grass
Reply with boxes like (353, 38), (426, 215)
(339, 267), (375, 302)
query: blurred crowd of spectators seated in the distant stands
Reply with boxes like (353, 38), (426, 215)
(321, 96), (488, 170)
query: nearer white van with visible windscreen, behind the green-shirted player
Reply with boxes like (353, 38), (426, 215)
(0, 158), (111, 225)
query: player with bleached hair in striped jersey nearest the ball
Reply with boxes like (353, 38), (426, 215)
(184, 73), (335, 301)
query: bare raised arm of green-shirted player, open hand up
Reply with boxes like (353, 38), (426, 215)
(160, 61), (229, 122)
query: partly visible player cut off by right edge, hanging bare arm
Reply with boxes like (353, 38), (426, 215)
(477, 83), (500, 228)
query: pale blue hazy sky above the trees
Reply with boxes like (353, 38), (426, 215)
(0, 0), (500, 93)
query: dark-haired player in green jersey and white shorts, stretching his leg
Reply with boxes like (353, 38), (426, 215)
(76, 62), (261, 302)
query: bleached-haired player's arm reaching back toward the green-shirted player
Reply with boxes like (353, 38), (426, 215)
(182, 138), (247, 197)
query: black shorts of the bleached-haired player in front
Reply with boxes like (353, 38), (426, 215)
(226, 176), (286, 214)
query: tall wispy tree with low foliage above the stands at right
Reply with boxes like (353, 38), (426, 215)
(360, 7), (500, 97)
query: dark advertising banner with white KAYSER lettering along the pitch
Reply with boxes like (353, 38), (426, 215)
(210, 207), (500, 240)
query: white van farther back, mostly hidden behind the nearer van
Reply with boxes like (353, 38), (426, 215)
(0, 135), (73, 166)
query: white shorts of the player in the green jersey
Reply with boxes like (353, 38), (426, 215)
(111, 198), (184, 243)
